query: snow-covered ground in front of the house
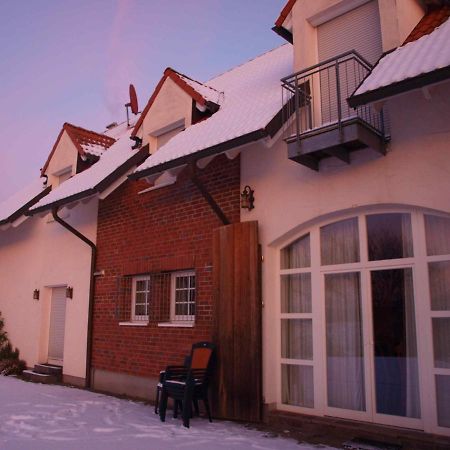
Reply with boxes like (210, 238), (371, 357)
(0, 376), (338, 450)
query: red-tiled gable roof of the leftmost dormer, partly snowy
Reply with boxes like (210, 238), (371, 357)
(41, 122), (116, 174)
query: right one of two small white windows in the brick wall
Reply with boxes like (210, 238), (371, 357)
(170, 271), (195, 322)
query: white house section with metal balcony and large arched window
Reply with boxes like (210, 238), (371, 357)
(246, 0), (450, 435)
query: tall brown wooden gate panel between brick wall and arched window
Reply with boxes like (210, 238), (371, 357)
(213, 222), (262, 422)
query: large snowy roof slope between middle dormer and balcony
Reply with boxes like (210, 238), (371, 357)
(131, 44), (293, 178)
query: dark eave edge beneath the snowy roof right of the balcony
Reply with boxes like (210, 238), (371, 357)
(347, 66), (450, 108)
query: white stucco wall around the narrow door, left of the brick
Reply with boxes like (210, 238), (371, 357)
(0, 192), (98, 378)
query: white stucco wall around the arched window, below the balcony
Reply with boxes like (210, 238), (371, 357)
(241, 83), (450, 403)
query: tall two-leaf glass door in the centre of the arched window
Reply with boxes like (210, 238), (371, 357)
(323, 266), (423, 429)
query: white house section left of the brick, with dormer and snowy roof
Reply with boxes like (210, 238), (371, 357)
(0, 123), (146, 385)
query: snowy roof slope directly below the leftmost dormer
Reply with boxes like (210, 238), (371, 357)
(30, 124), (148, 214)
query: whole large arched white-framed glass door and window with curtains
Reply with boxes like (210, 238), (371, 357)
(279, 210), (450, 434)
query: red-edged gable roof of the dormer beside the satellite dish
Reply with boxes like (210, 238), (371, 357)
(131, 67), (223, 136)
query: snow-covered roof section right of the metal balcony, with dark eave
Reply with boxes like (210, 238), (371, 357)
(349, 15), (450, 107)
